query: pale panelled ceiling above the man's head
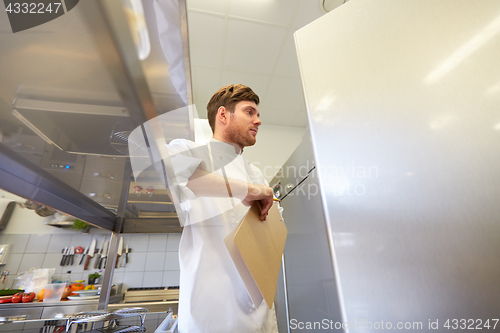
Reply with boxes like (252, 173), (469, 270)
(187, 0), (330, 127)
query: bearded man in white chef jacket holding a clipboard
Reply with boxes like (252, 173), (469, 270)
(166, 84), (278, 333)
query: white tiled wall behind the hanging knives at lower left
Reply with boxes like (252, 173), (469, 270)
(0, 233), (181, 291)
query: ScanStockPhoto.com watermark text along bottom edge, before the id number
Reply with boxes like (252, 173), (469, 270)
(290, 319), (424, 330)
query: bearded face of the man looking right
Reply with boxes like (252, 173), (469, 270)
(226, 101), (261, 148)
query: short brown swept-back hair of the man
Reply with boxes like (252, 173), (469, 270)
(207, 84), (260, 133)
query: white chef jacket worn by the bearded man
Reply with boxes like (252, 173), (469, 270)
(168, 139), (278, 333)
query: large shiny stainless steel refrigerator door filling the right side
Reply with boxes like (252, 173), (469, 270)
(273, 0), (500, 332)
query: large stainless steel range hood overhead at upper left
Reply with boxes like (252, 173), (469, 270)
(0, 0), (194, 229)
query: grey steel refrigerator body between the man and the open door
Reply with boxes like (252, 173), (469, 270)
(270, 131), (342, 333)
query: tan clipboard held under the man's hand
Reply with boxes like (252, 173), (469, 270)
(224, 203), (288, 309)
